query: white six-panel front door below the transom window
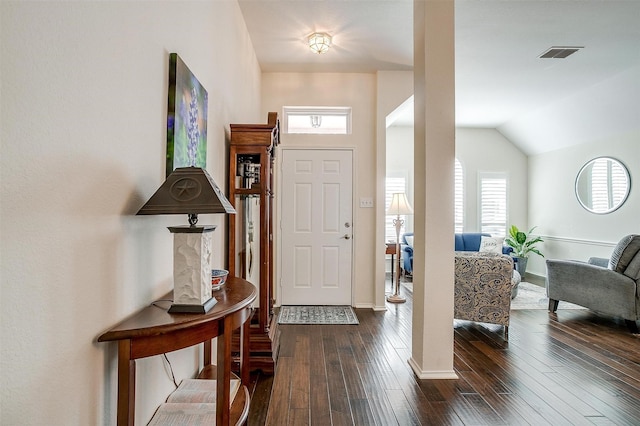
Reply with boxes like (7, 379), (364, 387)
(280, 149), (353, 305)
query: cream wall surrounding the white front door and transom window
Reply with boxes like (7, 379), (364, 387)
(262, 73), (376, 307)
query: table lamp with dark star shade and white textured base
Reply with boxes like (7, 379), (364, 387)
(136, 167), (236, 313)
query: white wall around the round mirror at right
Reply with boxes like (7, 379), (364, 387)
(527, 131), (640, 275)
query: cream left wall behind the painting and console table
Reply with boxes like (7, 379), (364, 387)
(0, 1), (266, 425)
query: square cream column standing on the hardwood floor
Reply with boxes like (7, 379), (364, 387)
(409, 0), (457, 379)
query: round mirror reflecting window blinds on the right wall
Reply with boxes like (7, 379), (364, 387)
(575, 157), (631, 214)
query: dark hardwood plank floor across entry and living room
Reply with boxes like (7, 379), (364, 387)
(248, 282), (640, 426)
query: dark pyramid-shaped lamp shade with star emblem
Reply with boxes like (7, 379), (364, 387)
(136, 167), (236, 215)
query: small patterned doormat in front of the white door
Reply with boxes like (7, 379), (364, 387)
(278, 306), (360, 325)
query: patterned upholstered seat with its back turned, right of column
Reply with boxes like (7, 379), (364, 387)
(453, 252), (513, 336)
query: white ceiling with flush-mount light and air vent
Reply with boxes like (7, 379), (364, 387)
(239, 0), (640, 154)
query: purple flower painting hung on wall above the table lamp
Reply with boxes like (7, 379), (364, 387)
(167, 53), (208, 176)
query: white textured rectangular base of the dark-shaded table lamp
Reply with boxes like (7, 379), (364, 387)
(169, 226), (216, 313)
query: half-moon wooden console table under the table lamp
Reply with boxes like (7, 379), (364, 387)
(98, 277), (257, 426)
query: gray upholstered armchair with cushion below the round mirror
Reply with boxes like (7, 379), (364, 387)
(547, 235), (640, 333)
